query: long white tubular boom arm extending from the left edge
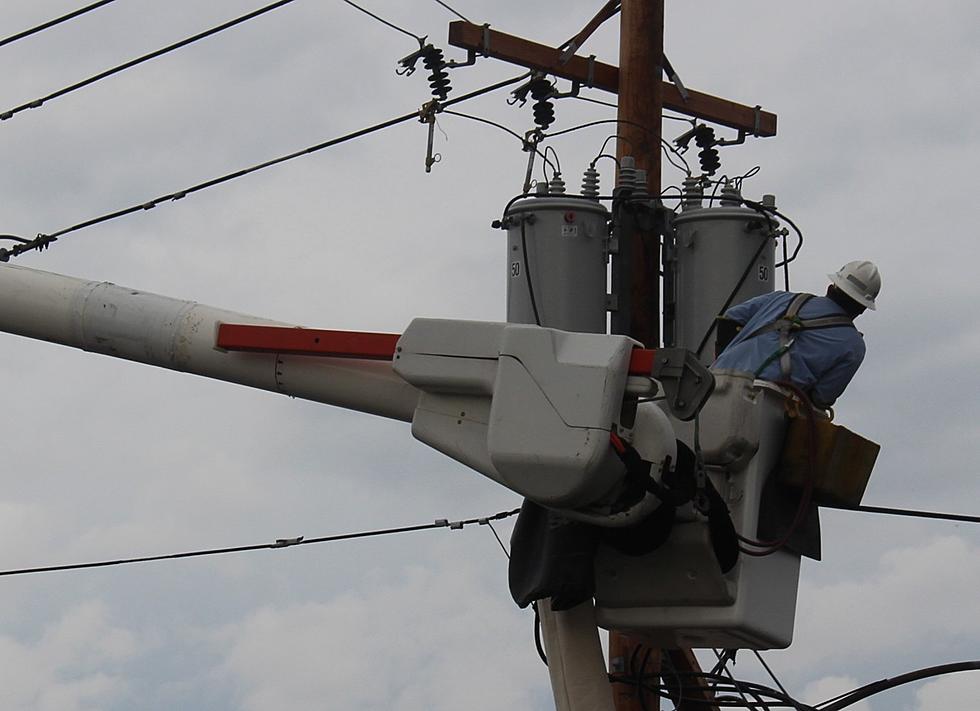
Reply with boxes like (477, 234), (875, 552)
(0, 265), (419, 422)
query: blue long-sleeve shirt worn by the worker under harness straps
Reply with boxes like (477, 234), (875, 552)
(712, 291), (865, 407)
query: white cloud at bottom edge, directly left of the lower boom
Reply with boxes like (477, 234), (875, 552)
(220, 563), (547, 711)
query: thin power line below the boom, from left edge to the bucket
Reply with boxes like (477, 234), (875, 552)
(0, 509), (520, 577)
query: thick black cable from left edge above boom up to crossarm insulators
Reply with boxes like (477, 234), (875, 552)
(0, 74), (527, 262)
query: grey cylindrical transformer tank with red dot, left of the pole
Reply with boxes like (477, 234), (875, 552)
(504, 196), (609, 333)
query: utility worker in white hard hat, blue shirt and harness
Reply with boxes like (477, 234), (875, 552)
(712, 261), (881, 408)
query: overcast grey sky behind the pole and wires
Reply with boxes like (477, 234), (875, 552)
(0, 0), (980, 711)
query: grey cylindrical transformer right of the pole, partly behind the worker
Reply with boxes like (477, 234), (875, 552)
(667, 188), (777, 365)
